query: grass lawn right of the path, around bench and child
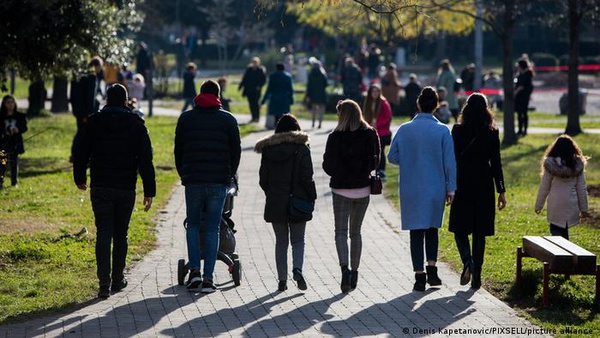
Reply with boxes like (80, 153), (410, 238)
(385, 135), (600, 332)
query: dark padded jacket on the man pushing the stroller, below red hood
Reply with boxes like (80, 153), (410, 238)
(175, 101), (242, 185)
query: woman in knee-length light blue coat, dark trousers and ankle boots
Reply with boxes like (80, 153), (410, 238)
(388, 87), (456, 291)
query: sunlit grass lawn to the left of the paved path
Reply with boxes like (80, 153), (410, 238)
(0, 114), (254, 323)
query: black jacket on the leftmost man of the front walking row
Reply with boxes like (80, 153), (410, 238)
(73, 106), (156, 197)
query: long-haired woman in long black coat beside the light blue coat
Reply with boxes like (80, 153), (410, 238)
(449, 93), (506, 289)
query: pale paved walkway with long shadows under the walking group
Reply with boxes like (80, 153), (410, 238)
(0, 109), (552, 338)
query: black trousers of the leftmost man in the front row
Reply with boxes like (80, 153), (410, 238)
(90, 187), (135, 288)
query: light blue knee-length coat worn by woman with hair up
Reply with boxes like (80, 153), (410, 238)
(388, 113), (456, 230)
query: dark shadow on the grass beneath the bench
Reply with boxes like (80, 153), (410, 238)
(504, 269), (599, 326)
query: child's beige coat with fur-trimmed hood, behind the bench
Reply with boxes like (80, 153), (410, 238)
(535, 157), (588, 228)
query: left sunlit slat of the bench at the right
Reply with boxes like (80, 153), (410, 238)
(523, 236), (575, 270)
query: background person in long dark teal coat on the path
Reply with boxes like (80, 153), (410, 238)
(261, 62), (294, 129)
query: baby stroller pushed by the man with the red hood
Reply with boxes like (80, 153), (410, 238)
(177, 179), (242, 286)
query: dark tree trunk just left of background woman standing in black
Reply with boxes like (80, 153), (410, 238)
(501, 0), (517, 145)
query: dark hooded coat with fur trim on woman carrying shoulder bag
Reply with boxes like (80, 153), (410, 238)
(254, 131), (317, 223)
